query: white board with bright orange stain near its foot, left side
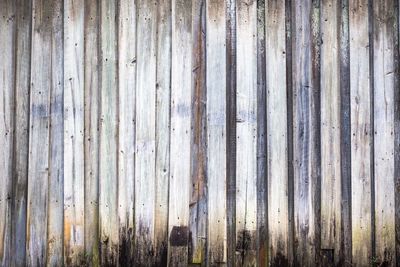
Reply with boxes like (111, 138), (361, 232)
(64, 0), (85, 265)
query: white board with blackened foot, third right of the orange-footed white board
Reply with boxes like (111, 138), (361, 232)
(118, 0), (136, 266)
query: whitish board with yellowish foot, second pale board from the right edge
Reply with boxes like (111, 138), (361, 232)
(349, 0), (372, 266)
